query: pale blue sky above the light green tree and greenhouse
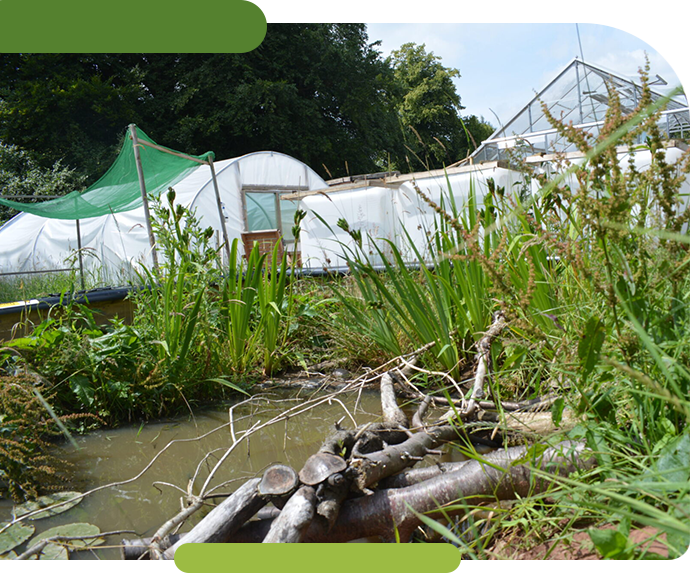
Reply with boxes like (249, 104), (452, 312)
(367, 23), (690, 126)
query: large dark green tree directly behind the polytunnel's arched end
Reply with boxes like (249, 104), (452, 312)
(134, 24), (401, 177)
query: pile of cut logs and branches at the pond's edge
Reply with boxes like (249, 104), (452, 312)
(123, 315), (594, 559)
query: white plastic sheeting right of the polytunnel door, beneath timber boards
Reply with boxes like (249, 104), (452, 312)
(300, 163), (522, 270)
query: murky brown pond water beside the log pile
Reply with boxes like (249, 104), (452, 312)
(0, 391), (388, 559)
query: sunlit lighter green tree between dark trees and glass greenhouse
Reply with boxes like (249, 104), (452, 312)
(387, 43), (493, 171)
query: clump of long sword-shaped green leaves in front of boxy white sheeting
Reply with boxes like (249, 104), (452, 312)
(335, 179), (560, 380)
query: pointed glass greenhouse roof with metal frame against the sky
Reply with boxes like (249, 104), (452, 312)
(472, 59), (690, 162)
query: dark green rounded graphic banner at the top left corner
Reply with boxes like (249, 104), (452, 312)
(0, 0), (266, 53)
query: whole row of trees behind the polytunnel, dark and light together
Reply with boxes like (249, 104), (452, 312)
(0, 24), (490, 190)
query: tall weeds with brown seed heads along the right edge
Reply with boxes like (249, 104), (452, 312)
(476, 65), (690, 559)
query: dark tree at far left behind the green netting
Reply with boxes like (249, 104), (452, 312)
(0, 54), (142, 181)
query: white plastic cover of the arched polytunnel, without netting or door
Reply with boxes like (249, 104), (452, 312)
(0, 151), (326, 285)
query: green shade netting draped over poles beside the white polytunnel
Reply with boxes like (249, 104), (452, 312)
(0, 127), (213, 219)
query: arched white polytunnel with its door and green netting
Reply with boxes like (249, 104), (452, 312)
(0, 126), (326, 286)
